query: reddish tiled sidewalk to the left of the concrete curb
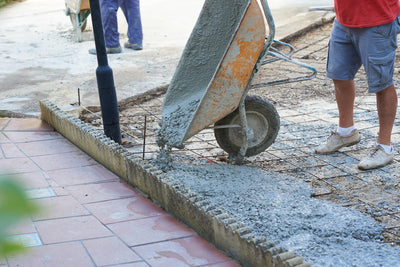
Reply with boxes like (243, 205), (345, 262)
(0, 118), (240, 267)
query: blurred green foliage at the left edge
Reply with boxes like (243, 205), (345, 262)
(0, 174), (38, 258)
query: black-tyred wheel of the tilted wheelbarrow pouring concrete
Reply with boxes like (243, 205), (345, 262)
(214, 96), (280, 157)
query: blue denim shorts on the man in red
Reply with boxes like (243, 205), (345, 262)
(327, 16), (400, 93)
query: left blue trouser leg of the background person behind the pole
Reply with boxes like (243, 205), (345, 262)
(100, 0), (120, 48)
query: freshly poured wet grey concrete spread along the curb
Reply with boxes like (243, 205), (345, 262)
(161, 158), (400, 267)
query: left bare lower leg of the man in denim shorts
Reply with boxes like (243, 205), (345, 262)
(333, 80), (356, 128)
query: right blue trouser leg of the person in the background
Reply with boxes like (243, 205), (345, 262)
(121, 0), (143, 48)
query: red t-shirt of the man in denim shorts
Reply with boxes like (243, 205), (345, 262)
(335, 0), (400, 28)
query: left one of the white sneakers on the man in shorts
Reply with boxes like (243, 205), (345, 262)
(315, 129), (360, 154)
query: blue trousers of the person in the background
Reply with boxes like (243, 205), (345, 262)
(100, 0), (143, 48)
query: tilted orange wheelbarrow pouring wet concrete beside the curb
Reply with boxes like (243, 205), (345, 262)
(158, 0), (317, 164)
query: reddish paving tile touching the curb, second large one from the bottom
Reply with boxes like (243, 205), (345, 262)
(107, 215), (196, 246)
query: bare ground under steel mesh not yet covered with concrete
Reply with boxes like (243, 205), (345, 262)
(81, 23), (400, 249)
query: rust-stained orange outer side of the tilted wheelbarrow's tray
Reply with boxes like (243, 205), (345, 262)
(184, 1), (266, 140)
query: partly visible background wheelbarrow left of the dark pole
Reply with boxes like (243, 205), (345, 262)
(65, 0), (90, 42)
